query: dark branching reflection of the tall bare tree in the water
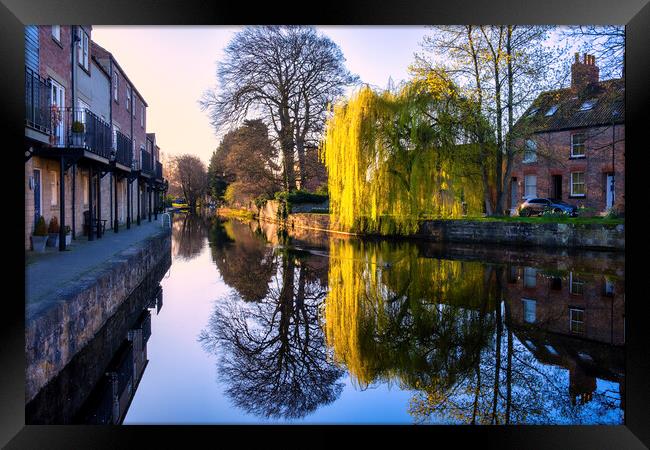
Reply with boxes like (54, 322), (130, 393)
(199, 253), (343, 419)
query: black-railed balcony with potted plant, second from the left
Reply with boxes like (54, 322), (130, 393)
(50, 106), (113, 159)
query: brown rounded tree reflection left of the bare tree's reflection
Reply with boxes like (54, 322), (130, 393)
(210, 219), (276, 301)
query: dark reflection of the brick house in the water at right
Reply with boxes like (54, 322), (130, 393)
(505, 266), (625, 407)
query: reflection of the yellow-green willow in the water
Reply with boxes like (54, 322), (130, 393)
(324, 239), (495, 389)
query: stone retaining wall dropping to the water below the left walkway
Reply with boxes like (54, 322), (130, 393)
(25, 229), (171, 402)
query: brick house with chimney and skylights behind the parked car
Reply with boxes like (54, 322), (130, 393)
(508, 53), (625, 215)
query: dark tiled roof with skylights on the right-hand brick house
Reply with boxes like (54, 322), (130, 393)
(514, 78), (625, 133)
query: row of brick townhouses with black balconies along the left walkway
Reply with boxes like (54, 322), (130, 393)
(25, 25), (166, 250)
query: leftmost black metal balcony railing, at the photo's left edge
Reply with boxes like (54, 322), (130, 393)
(25, 67), (52, 134)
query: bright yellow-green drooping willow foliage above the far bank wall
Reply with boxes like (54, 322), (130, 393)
(321, 76), (483, 234)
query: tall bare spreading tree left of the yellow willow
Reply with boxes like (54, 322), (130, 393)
(200, 26), (358, 190)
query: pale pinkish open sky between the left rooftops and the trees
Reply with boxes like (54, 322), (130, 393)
(92, 26), (427, 165)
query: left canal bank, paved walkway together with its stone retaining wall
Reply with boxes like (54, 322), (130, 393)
(25, 219), (171, 402)
